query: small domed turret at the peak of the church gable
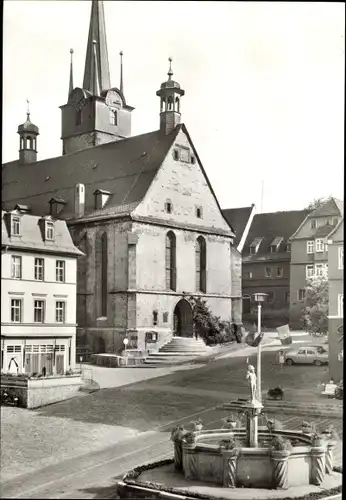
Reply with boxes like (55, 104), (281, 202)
(156, 57), (185, 135)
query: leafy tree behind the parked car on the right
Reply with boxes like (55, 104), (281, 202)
(302, 276), (329, 333)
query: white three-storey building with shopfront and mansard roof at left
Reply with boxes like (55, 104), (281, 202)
(1, 205), (83, 375)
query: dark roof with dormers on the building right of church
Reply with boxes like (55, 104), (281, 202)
(243, 210), (310, 257)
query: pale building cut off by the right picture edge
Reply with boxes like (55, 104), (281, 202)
(325, 219), (344, 382)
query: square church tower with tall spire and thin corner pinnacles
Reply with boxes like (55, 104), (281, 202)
(60, 0), (134, 154)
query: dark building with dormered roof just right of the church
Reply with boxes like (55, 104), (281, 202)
(242, 210), (308, 328)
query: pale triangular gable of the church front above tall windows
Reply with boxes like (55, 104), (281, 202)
(133, 126), (233, 235)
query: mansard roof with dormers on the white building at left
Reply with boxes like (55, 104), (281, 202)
(1, 210), (83, 257)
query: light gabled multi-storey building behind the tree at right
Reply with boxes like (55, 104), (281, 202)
(290, 198), (343, 329)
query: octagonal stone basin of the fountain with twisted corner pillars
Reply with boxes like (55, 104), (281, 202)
(182, 429), (327, 489)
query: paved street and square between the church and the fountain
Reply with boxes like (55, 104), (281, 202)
(1, 347), (342, 498)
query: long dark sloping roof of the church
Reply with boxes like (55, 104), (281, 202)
(2, 125), (183, 219)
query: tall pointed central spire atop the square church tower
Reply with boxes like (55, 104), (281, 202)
(83, 0), (111, 93)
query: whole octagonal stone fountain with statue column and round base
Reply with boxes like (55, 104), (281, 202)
(118, 365), (342, 499)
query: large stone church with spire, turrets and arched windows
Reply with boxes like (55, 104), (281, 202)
(2, 0), (242, 353)
